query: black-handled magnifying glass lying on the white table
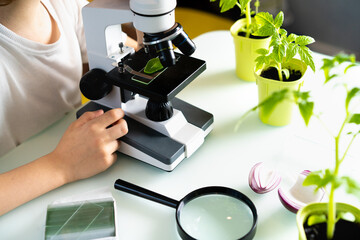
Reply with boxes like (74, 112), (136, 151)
(114, 179), (257, 240)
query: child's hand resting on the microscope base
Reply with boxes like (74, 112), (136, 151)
(50, 109), (128, 182)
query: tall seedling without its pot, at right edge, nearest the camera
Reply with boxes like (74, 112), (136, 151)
(236, 54), (360, 239)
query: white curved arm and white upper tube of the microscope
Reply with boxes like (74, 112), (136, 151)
(82, 0), (176, 72)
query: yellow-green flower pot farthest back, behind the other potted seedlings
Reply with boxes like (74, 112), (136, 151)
(230, 19), (270, 82)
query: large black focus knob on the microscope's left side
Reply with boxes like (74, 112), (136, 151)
(80, 68), (112, 100)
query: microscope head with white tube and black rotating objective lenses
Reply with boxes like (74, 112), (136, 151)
(130, 0), (196, 67)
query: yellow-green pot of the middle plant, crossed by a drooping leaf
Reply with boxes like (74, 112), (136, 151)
(254, 59), (307, 126)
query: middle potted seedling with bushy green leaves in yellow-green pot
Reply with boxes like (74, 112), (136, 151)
(252, 12), (315, 126)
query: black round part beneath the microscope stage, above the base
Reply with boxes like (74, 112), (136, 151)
(145, 99), (174, 122)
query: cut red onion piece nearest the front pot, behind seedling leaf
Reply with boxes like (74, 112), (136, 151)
(278, 170), (325, 213)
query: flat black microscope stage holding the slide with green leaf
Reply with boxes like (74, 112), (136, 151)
(106, 49), (206, 102)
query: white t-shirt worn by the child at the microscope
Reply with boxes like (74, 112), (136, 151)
(0, 0), (88, 156)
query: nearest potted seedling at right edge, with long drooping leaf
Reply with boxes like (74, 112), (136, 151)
(236, 47), (360, 237)
